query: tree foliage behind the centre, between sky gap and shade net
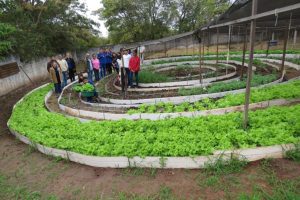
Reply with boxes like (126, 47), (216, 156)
(99, 0), (230, 43)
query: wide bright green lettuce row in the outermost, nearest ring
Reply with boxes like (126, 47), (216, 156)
(9, 82), (300, 157)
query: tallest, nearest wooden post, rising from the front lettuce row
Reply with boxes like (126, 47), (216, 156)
(244, 0), (257, 129)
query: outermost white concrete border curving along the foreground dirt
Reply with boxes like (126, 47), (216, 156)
(7, 84), (295, 169)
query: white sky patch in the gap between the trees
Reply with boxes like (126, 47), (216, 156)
(80, 0), (108, 37)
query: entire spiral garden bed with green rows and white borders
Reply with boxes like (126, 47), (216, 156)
(8, 54), (300, 168)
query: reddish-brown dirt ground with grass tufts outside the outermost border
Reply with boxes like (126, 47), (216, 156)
(0, 82), (300, 199)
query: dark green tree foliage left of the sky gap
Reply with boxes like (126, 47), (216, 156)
(0, 0), (102, 60)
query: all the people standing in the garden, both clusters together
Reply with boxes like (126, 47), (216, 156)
(47, 48), (142, 97)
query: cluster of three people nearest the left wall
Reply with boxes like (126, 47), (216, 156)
(47, 53), (76, 94)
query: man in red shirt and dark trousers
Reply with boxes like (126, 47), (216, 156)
(128, 50), (141, 87)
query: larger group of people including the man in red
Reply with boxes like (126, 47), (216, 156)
(86, 48), (141, 87)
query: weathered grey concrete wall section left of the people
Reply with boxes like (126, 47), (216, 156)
(0, 56), (49, 96)
